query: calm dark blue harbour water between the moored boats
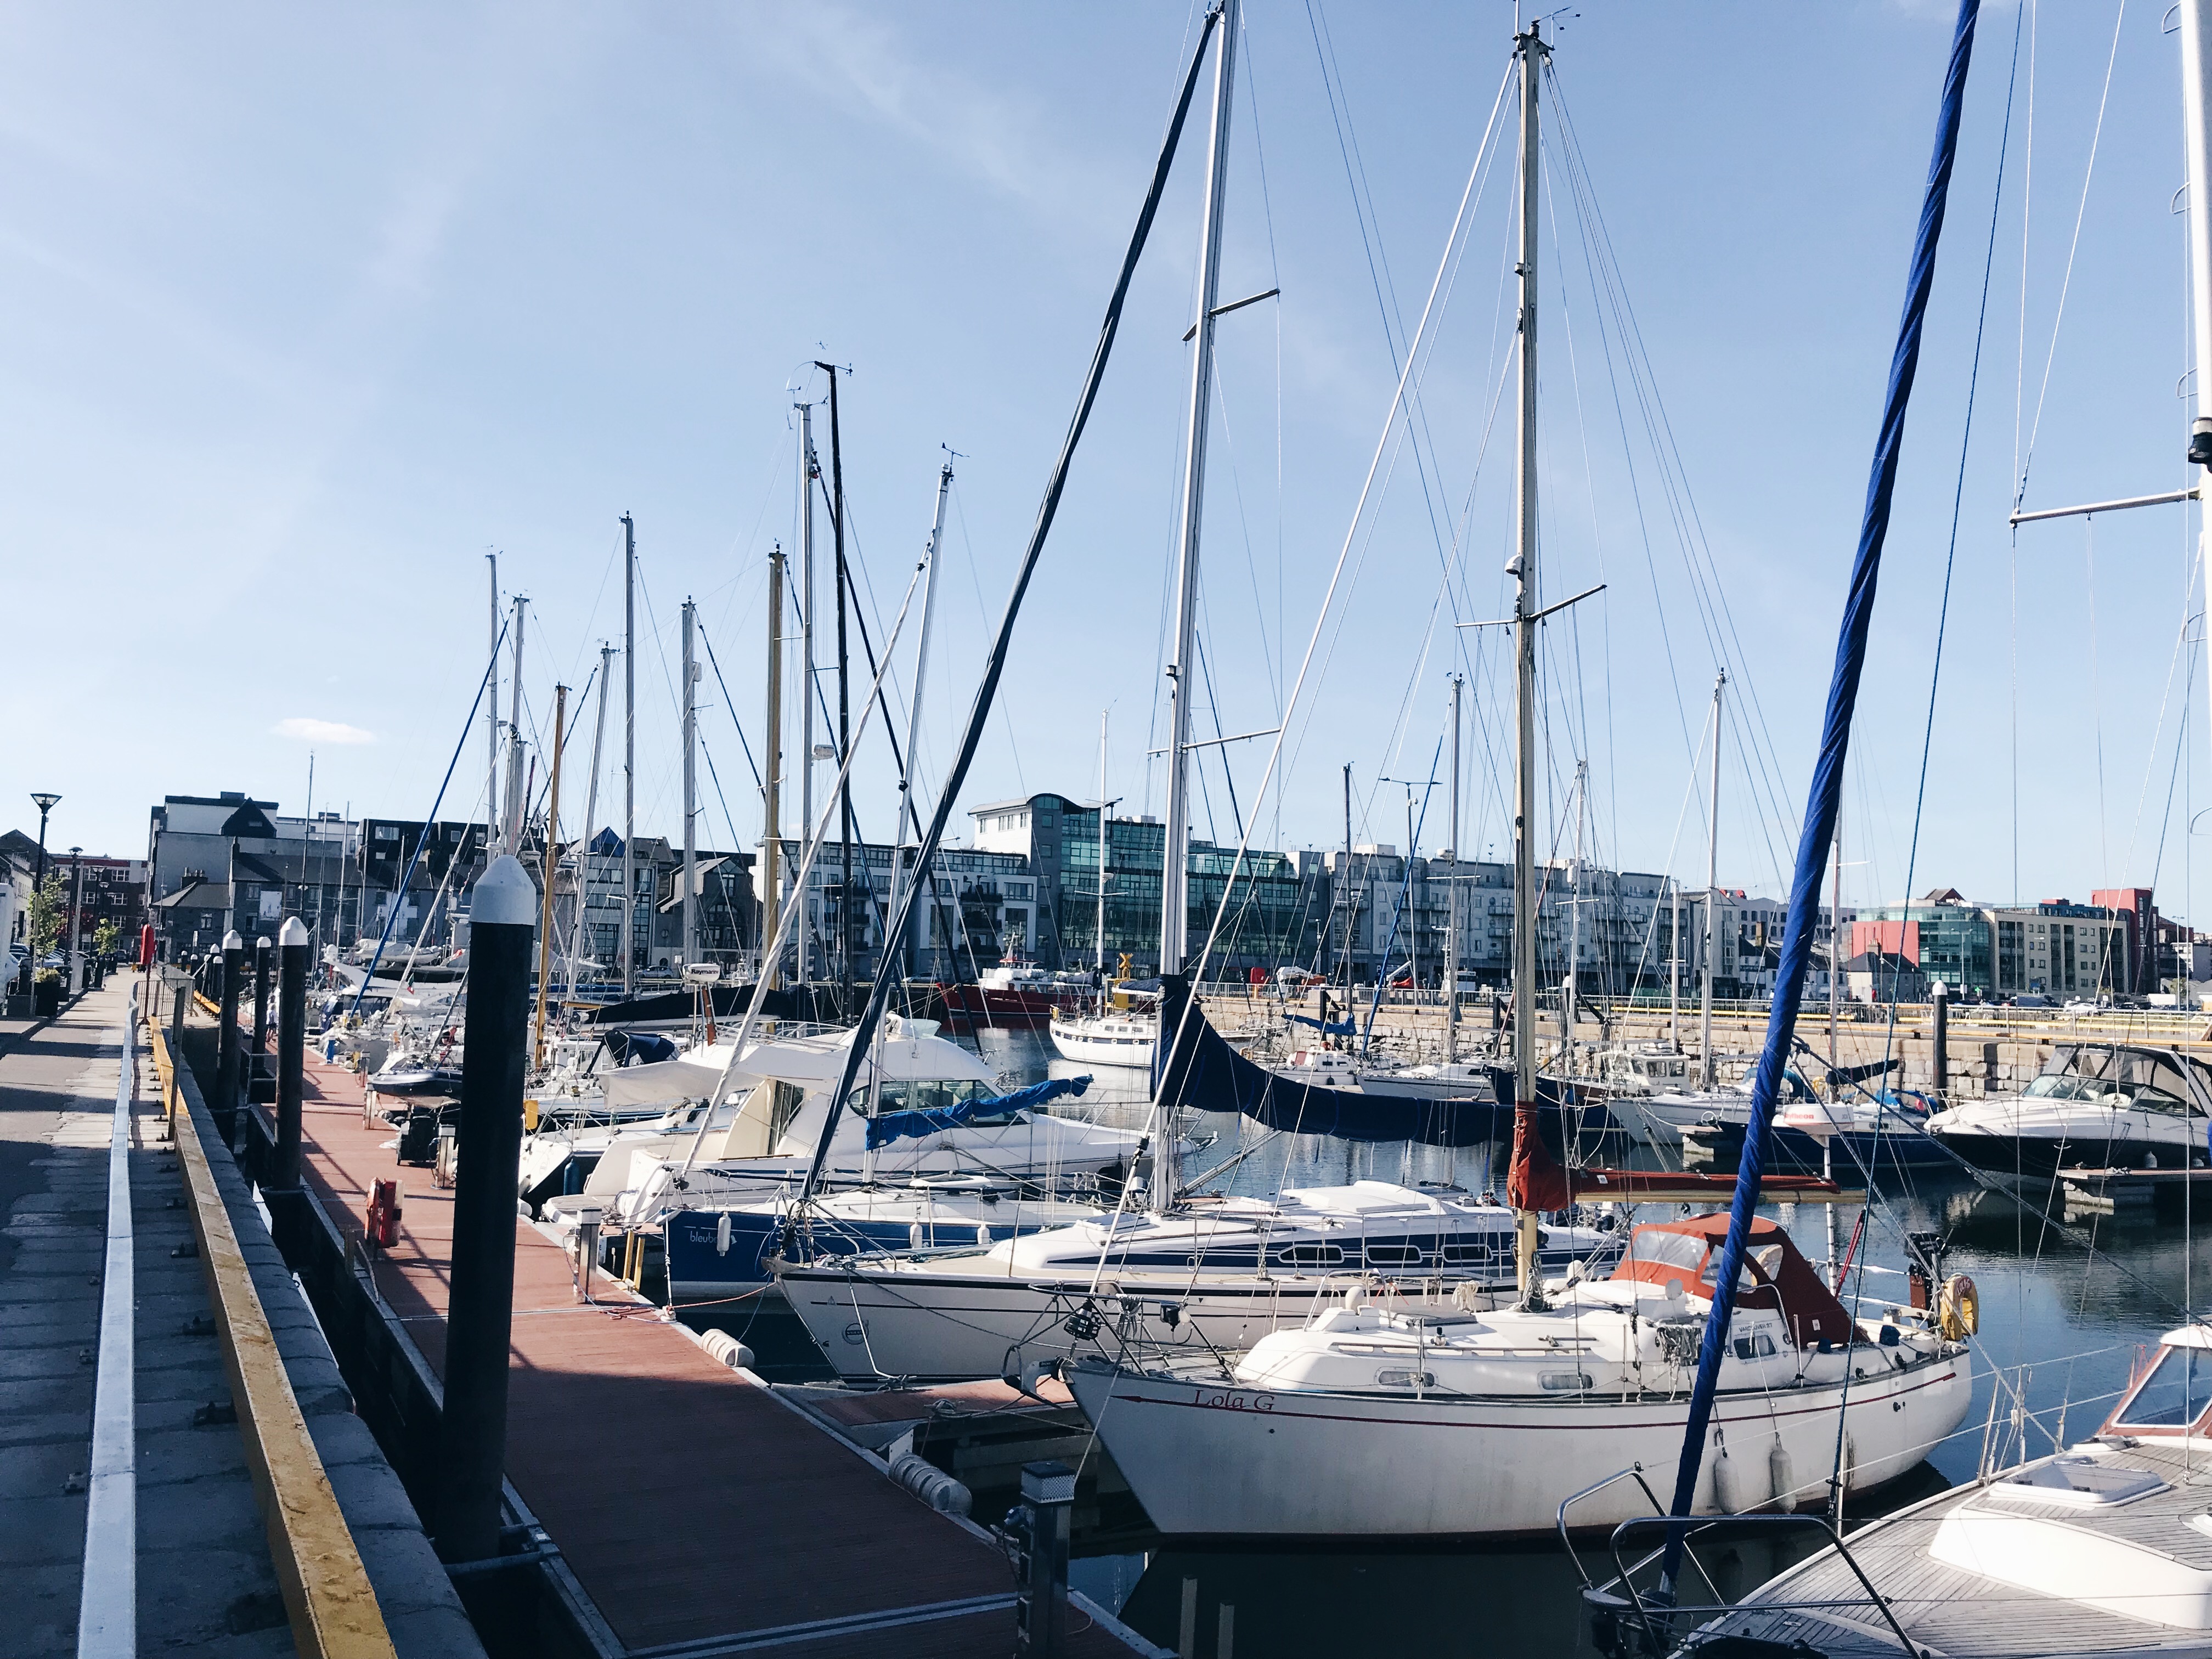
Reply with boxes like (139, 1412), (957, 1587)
(708, 1031), (2212, 1659)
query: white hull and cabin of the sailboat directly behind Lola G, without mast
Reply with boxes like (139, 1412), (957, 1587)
(776, 1181), (1619, 1383)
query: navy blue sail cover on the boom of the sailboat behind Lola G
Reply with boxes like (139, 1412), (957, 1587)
(1153, 973), (1513, 1146)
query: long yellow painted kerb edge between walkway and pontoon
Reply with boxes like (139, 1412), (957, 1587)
(148, 1022), (394, 1659)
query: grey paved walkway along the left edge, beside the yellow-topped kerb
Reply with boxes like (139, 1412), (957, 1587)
(0, 982), (292, 1659)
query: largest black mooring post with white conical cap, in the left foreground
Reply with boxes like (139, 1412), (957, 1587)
(436, 854), (538, 1562)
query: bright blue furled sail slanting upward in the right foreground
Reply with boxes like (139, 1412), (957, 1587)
(1661, 0), (1980, 1586)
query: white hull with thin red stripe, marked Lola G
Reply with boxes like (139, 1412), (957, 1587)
(1068, 1354), (1973, 1537)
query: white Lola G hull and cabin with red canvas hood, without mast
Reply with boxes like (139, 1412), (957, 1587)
(1064, 1215), (1973, 1537)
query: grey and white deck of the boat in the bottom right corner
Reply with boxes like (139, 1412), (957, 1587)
(1681, 1442), (2212, 1659)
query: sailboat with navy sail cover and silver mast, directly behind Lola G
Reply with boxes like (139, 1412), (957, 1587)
(776, 0), (1619, 1380)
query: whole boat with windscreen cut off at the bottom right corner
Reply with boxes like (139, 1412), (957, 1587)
(1654, 1325), (2212, 1659)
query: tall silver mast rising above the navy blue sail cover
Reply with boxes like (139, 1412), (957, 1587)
(1159, 0), (1239, 973)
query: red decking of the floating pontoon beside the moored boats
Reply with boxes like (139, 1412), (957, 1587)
(290, 1057), (1130, 1659)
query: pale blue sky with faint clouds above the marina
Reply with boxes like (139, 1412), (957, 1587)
(0, 0), (2212, 938)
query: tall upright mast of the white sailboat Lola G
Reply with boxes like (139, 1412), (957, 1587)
(1506, 24), (1544, 1292)
